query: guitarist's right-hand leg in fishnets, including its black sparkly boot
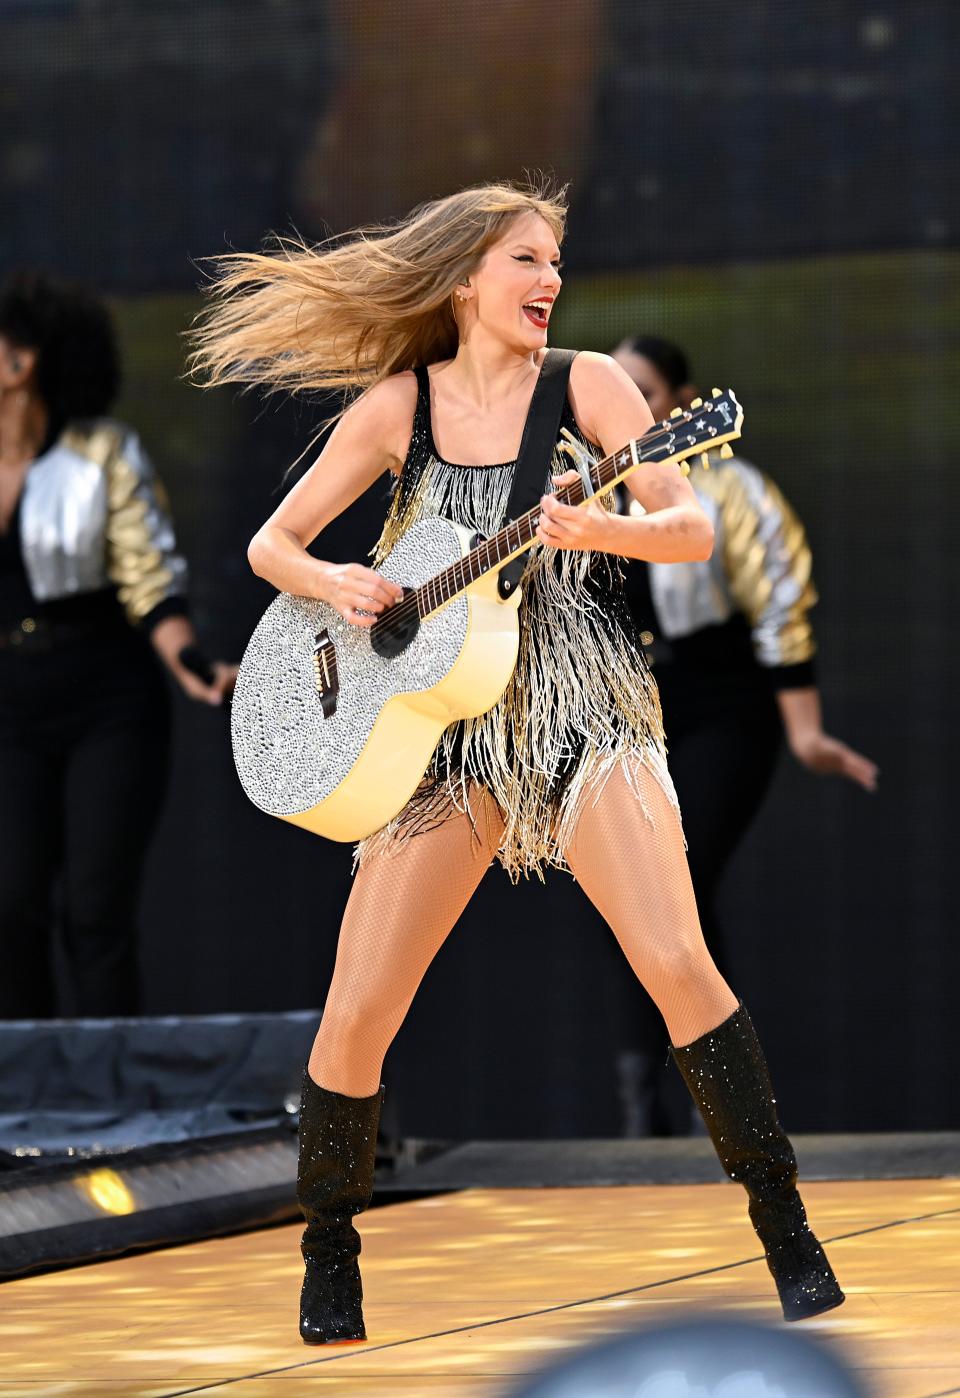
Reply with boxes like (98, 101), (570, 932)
(566, 769), (844, 1320)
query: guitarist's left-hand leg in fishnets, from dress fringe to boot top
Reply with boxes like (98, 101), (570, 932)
(309, 793), (503, 1097)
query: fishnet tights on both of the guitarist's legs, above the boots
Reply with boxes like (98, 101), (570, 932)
(310, 766), (738, 1097)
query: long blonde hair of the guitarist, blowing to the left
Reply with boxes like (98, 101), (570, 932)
(189, 182), (566, 393)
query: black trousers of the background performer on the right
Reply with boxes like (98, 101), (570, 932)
(620, 665), (783, 1135)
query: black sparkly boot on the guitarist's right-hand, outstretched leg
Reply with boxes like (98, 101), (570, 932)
(671, 1005), (844, 1320)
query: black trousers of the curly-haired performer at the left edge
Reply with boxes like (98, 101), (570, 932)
(0, 628), (169, 1019)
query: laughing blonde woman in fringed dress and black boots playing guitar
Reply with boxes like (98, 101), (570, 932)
(194, 185), (844, 1343)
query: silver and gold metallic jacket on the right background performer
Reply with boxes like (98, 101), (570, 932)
(630, 452), (817, 667)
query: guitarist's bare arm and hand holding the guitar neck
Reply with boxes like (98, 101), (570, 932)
(538, 354), (713, 563)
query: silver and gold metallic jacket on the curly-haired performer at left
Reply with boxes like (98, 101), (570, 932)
(20, 419), (187, 624)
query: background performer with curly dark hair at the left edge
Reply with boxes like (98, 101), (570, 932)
(0, 274), (236, 1019)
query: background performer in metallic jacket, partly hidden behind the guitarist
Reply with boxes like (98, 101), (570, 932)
(613, 336), (878, 1135)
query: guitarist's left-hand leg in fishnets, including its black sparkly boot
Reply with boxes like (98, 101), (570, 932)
(296, 793), (503, 1345)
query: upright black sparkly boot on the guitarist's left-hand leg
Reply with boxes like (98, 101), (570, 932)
(296, 1071), (383, 1345)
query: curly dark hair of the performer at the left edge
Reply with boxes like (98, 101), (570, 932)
(0, 271), (120, 429)
